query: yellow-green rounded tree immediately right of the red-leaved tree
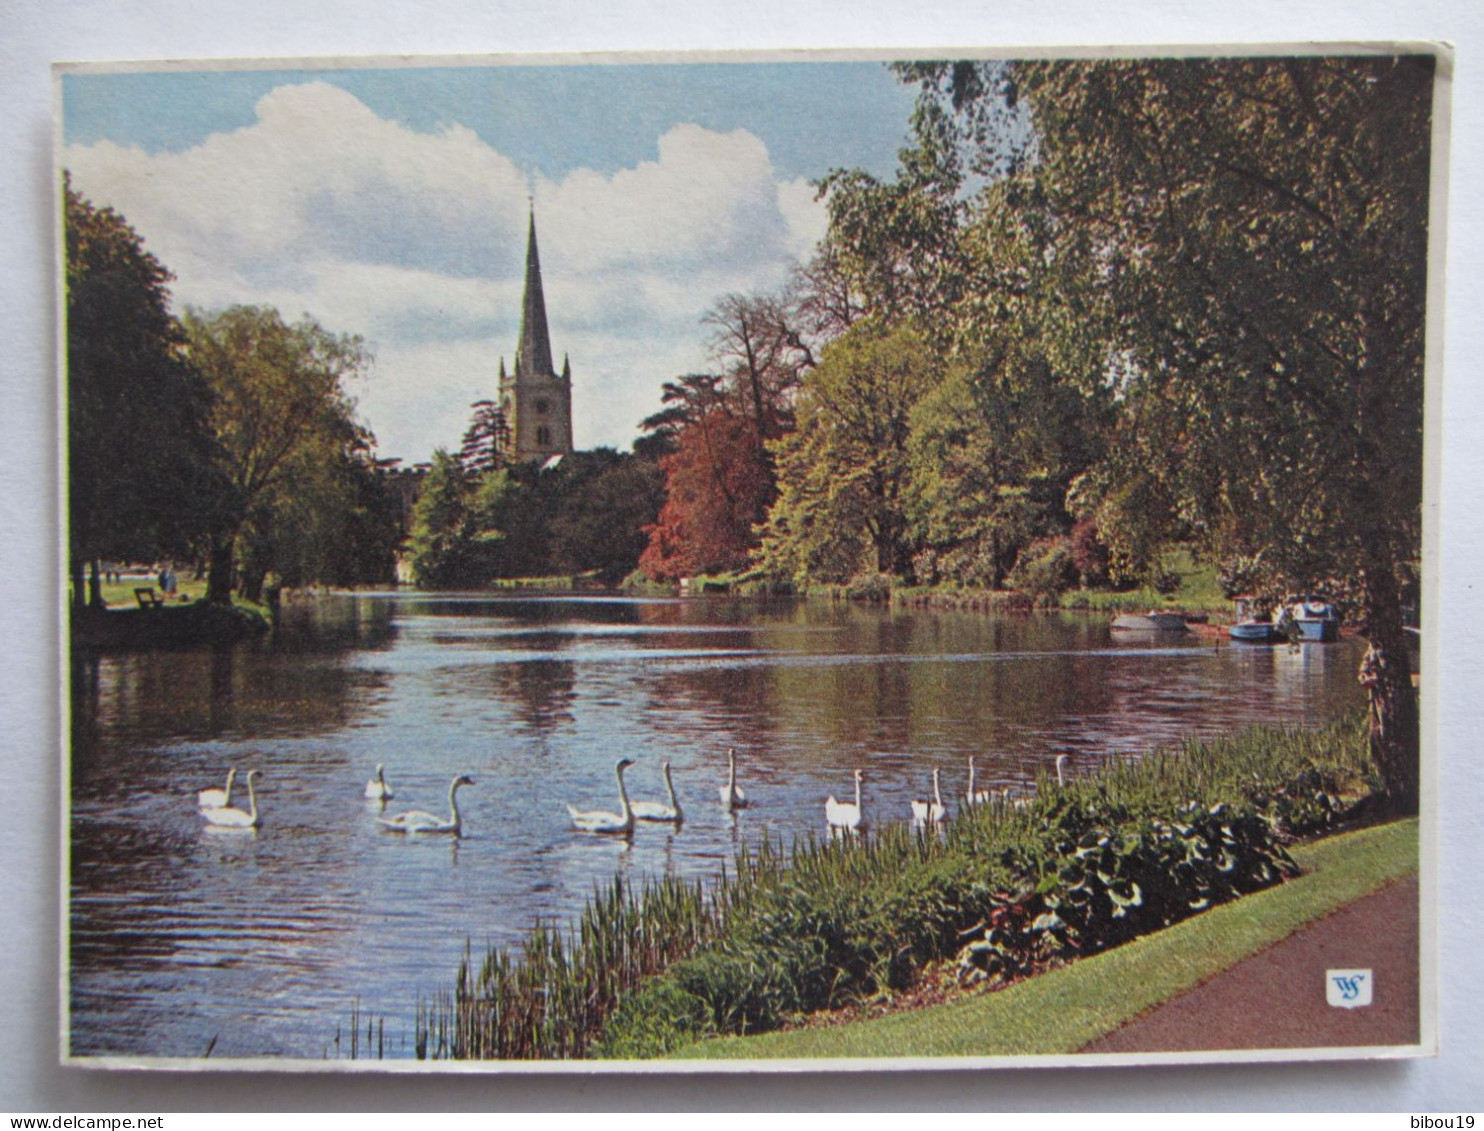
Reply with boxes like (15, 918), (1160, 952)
(758, 322), (939, 583)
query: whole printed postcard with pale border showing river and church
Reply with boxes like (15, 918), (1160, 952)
(55, 45), (1451, 1072)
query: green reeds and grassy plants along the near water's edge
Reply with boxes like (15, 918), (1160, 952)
(415, 718), (1371, 1060)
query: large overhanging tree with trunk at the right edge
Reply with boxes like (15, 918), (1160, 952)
(1014, 56), (1434, 812)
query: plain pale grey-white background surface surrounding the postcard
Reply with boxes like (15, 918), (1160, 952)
(0, 0), (1484, 1113)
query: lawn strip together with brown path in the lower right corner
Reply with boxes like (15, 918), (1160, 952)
(671, 819), (1420, 1060)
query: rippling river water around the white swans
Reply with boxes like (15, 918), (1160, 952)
(67, 594), (1361, 1060)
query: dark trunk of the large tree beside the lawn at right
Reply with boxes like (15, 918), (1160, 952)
(1361, 567), (1422, 816)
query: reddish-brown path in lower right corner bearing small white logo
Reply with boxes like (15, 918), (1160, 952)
(1082, 876), (1420, 1052)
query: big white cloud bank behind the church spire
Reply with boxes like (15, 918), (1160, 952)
(65, 82), (824, 462)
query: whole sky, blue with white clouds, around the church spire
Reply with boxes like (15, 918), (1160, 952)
(59, 61), (913, 463)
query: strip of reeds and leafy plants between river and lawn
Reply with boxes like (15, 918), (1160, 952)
(418, 721), (1370, 1058)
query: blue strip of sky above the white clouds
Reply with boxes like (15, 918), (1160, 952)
(62, 62), (913, 178)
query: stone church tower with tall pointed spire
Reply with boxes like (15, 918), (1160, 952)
(500, 206), (571, 463)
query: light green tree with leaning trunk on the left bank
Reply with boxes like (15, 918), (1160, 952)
(186, 306), (374, 603)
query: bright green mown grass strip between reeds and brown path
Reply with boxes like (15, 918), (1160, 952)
(671, 821), (1417, 1060)
